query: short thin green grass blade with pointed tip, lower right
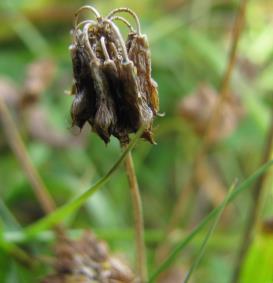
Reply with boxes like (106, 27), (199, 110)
(184, 182), (237, 283)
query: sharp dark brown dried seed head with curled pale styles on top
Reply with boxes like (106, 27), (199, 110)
(70, 6), (159, 144)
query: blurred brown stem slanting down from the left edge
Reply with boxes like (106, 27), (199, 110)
(0, 97), (55, 214)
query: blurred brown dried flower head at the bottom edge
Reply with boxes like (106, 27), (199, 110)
(42, 232), (137, 283)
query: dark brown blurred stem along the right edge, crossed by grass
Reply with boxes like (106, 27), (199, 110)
(231, 112), (273, 283)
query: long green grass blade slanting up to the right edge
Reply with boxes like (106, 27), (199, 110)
(148, 160), (273, 283)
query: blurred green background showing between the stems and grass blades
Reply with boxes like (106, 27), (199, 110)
(0, 0), (273, 283)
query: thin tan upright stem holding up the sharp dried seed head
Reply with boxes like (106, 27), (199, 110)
(124, 152), (147, 283)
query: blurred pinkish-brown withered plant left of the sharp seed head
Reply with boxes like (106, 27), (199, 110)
(0, 58), (84, 150)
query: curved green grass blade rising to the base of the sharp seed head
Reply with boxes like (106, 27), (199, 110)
(25, 128), (143, 237)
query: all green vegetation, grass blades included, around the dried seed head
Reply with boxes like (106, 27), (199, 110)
(0, 0), (273, 283)
